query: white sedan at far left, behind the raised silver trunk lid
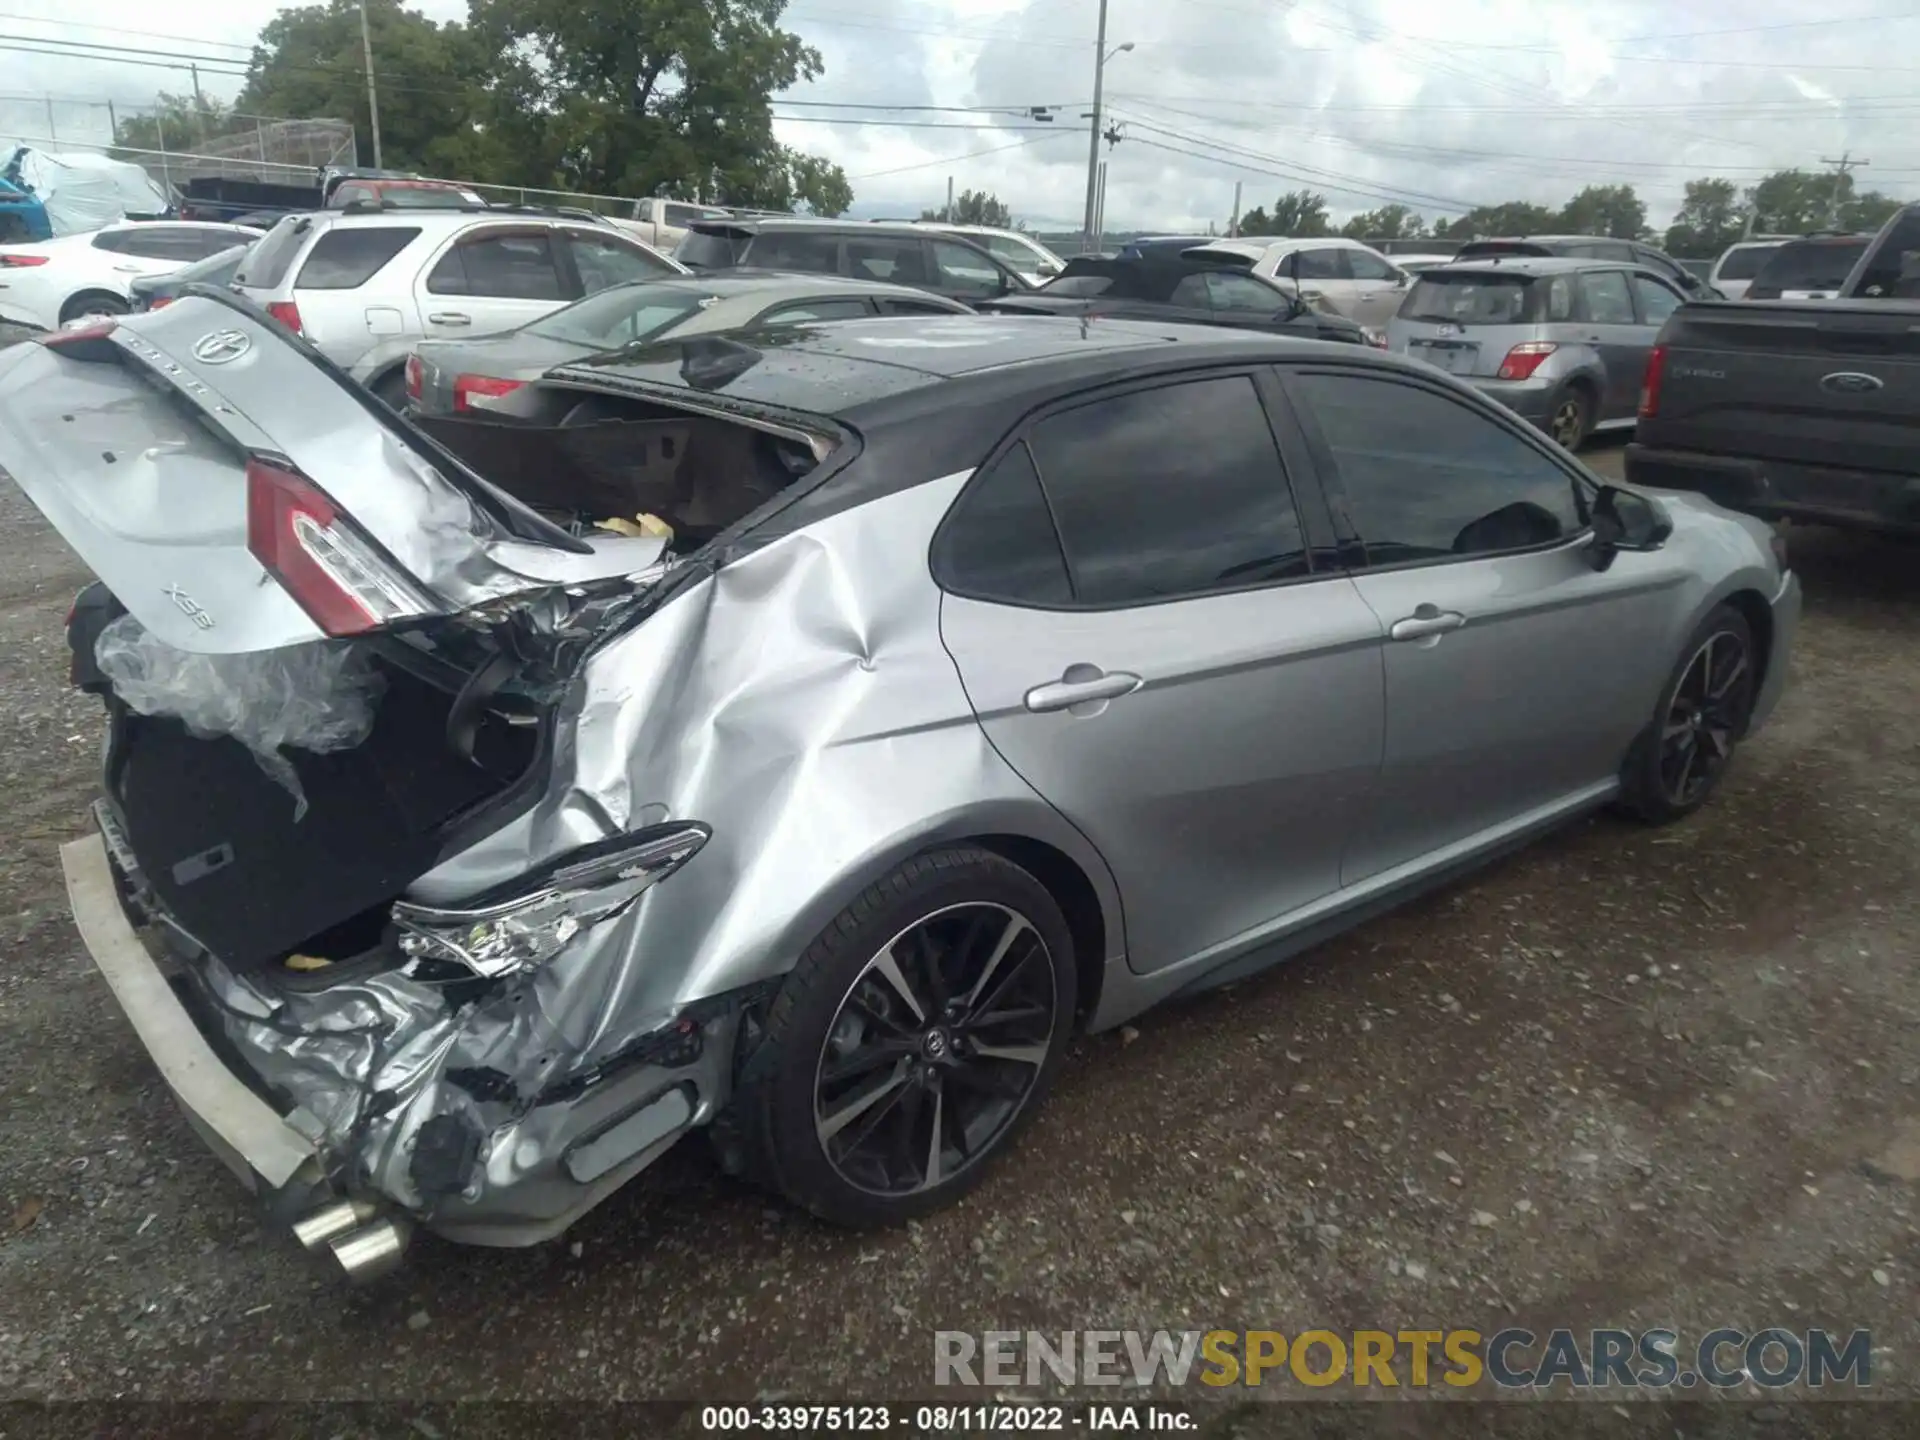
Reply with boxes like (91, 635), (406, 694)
(0, 221), (259, 330)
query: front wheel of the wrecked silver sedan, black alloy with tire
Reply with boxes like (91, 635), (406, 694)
(1620, 605), (1759, 826)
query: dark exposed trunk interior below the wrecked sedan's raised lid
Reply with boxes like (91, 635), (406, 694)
(106, 645), (541, 970)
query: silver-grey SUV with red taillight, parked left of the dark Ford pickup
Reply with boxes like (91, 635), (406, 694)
(1386, 255), (1686, 449)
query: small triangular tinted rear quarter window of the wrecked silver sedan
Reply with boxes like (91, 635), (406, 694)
(933, 445), (1073, 605)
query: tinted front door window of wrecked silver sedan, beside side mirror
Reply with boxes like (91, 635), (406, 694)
(1288, 374), (1586, 564)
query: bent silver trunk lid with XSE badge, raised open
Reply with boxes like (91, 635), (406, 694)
(0, 292), (664, 655)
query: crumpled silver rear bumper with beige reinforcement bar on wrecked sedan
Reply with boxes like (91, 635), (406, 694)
(61, 835), (739, 1252)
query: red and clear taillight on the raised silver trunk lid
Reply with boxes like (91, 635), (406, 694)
(246, 455), (440, 636)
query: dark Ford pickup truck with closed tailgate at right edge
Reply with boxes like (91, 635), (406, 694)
(1626, 205), (1920, 538)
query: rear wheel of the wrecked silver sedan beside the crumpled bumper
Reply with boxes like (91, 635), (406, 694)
(730, 847), (1075, 1229)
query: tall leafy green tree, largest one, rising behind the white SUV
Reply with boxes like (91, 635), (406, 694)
(464, 0), (852, 213)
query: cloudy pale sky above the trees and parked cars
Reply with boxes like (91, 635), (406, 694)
(0, 0), (1920, 230)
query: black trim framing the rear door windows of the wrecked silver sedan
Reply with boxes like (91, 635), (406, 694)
(925, 361), (1346, 614)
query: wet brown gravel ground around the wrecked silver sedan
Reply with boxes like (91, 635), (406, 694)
(0, 445), (1920, 1400)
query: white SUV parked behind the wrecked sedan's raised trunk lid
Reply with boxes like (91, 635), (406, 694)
(234, 207), (685, 409)
